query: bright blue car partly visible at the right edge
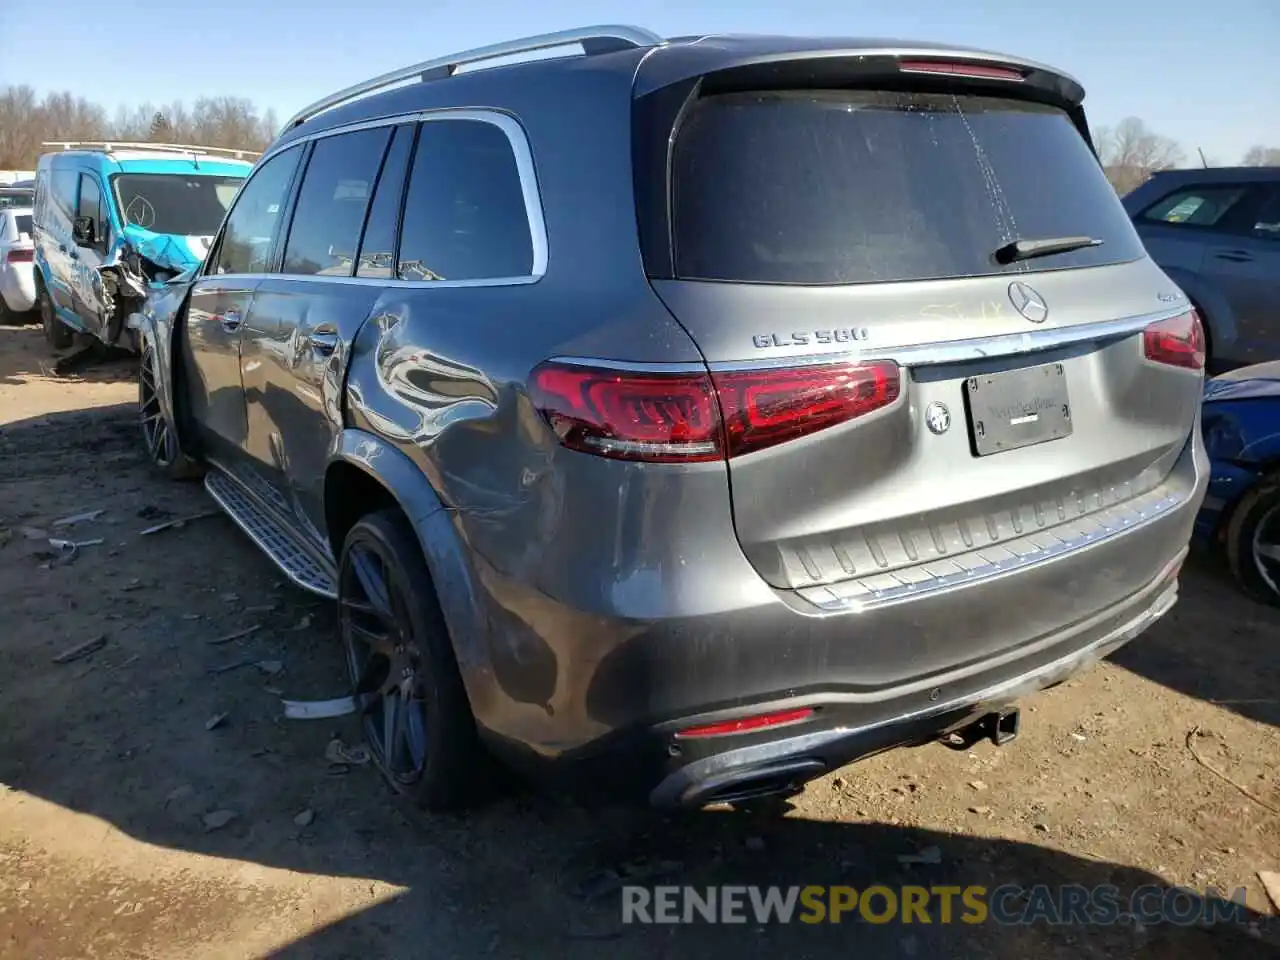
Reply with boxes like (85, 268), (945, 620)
(1196, 361), (1280, 605)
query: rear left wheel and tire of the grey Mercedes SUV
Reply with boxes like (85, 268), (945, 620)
(338, 509), (494, 810)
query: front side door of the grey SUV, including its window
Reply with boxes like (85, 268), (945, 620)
(183, 147), (302, 468)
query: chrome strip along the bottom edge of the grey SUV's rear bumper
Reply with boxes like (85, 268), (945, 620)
(649, 568), (1187, 806)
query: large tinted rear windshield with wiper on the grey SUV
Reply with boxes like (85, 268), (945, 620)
(672, 91), (1142, 284)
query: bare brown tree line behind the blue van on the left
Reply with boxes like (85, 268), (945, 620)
(0, 86), (280, 170)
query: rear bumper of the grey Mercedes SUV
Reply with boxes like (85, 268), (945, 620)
(473, 430), (1208, 805)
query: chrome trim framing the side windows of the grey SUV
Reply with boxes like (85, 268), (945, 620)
(217, 106), (550, 289)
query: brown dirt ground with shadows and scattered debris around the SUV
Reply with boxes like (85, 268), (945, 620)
(0, 328), (1280, 960)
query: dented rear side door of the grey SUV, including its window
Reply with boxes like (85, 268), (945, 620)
(241, 125), (401, 543)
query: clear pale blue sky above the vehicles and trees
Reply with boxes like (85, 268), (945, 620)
(0, 0), (1280, 163)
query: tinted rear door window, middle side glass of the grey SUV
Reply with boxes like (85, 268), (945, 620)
(283, 127), (390, 276)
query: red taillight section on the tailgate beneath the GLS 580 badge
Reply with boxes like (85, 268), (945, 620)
(712, 362), (901, 457)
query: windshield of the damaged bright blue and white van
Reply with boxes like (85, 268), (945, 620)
(114, 173), (244, 237)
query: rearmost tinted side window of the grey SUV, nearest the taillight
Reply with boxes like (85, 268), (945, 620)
(397, 120), (534, 280)
